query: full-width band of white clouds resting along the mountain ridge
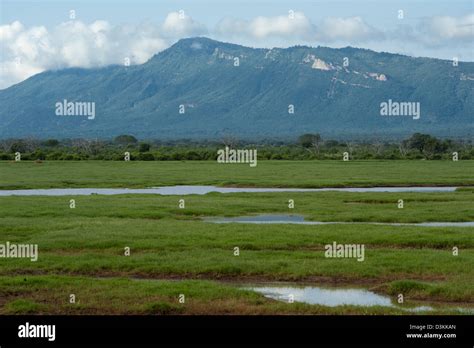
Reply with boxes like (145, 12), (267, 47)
(0, 11), (474, 89)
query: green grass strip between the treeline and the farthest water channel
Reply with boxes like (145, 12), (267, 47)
(0, 160), (474, 189)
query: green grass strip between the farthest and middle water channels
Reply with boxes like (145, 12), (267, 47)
(0, 189), (474, 224)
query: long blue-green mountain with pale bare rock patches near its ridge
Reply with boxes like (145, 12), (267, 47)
(0, 37), (474, 139)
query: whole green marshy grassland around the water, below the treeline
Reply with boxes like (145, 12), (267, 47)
(0, 161), (474, 314)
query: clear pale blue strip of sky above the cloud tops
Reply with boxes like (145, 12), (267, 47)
(1, 0), (474, 26)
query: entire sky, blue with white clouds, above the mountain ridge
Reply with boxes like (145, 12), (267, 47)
(0, 0), (474, 88)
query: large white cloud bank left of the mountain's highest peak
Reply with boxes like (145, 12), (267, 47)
(0, 12), (205, 88)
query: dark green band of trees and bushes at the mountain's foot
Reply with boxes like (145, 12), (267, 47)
(0, 133), (474, 161)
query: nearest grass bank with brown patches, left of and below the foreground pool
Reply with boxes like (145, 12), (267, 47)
(0, 276), (466, 315)
